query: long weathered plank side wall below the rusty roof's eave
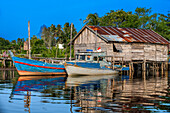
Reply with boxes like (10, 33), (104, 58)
(113, 43), (168, 61)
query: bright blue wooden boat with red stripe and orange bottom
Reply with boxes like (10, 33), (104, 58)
(9, 51), (66, 75)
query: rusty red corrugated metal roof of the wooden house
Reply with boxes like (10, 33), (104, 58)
(73, 25), (170, 44)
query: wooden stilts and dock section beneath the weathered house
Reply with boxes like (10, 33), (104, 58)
(107, 56), (170, 77)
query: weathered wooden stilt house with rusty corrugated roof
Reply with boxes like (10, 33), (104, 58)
(72, 25), (170, 61)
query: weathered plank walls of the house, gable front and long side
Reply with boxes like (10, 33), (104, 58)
(74, 28), (168, 61)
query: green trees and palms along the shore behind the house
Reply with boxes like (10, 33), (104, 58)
(0, 8), (170, 61)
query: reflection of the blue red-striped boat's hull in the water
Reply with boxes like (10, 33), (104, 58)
(13, 76), (66, 95)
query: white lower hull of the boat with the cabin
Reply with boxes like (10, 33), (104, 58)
(65, 65), (118, 76)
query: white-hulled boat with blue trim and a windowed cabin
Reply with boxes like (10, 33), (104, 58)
(64, 51), (117, 76)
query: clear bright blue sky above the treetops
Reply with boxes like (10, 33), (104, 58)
(0, 0), (170, 41)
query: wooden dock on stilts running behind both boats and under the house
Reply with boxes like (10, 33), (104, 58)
(0, 56), (170, 77)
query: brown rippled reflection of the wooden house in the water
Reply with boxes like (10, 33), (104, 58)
(66, 73), (170, 113)
